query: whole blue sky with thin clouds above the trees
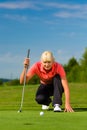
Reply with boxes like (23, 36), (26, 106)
(0, 0), (87, 79)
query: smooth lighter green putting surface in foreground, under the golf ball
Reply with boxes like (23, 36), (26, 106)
(0, 111), (87, 130)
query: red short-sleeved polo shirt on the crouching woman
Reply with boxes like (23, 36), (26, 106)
(27, 62), (66, 84)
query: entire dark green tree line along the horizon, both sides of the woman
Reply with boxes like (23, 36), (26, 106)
(0, 48), (87, 86)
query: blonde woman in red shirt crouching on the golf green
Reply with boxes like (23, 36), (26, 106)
(20, 51), (74, 112)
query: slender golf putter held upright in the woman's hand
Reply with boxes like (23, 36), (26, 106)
(18, 49), (30, 112)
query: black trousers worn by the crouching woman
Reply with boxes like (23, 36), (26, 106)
(35, 75), (64, 105)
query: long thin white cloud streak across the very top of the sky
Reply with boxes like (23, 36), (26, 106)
(0, 1), (87, 10)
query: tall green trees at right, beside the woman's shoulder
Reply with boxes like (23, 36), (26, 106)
(63, 48), (87, 82)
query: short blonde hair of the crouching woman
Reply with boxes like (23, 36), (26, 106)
(41, 51), (55, 62)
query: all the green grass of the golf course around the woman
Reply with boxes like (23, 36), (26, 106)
(0, 83), (87, 130)
